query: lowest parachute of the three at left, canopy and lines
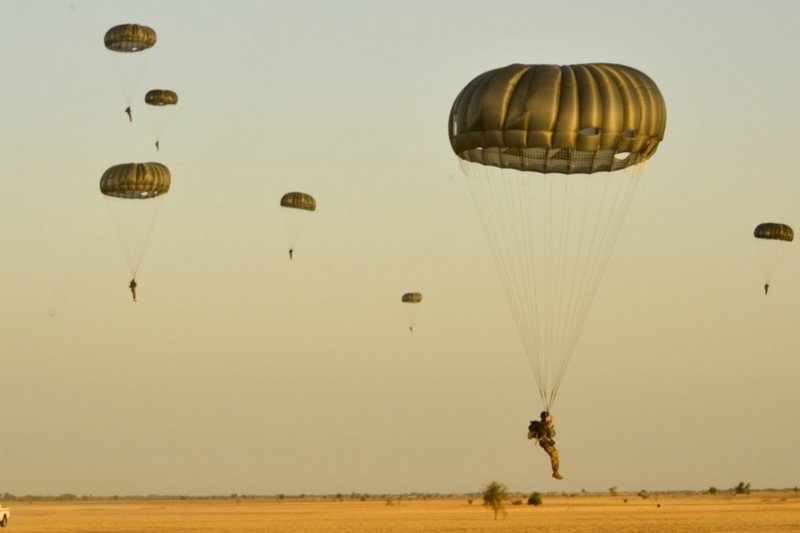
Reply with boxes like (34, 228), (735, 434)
(100, 163), (171, 278)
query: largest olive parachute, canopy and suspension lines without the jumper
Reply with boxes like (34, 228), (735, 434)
(448, 63), (666, 411)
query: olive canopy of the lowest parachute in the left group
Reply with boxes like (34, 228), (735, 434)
(100, 163), (171, 200)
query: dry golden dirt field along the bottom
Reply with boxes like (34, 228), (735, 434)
(4, 493), (800, 533)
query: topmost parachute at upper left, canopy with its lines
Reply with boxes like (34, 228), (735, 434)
(103, 24), (157, 117)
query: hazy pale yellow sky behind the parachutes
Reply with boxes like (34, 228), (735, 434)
(0, 0), (800, 495)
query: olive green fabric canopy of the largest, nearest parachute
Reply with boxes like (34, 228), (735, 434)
(448, 63), (667, 174)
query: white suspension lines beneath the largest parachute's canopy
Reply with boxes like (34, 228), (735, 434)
(460, 150), (643, 409)
